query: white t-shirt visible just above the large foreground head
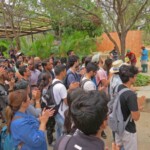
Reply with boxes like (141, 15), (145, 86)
(82, 77), (96, 91)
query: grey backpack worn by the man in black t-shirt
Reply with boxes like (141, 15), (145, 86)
(108, 85), (131, 136)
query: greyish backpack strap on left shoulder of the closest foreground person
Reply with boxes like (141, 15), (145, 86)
(58, 135), (72, 150)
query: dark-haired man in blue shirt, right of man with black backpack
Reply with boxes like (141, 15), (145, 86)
(65, 55), (80, 88)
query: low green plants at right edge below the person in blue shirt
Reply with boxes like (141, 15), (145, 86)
(134, 74), (150, 86)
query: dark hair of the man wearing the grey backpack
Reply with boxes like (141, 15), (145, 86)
(119, 65), (138, 83)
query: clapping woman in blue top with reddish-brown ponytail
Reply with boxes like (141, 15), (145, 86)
(6, 90), (54, 150)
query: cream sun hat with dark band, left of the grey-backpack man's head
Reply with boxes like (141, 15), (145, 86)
(109, 59), (124, 73)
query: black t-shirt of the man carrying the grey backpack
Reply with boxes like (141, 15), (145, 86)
(118, 84), (138, 133)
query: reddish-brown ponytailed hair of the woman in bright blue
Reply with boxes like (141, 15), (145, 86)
(5, 90), (27, 132)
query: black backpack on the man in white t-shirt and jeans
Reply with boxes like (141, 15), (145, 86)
(41, 81), (63, 115)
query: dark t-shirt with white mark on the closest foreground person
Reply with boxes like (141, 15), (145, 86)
(54, 130), (104, 150)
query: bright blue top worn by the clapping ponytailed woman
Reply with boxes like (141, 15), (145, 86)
(10, 112), (47, 150)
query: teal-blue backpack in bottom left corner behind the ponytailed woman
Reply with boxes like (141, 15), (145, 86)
(0, 126), (17, 150)
